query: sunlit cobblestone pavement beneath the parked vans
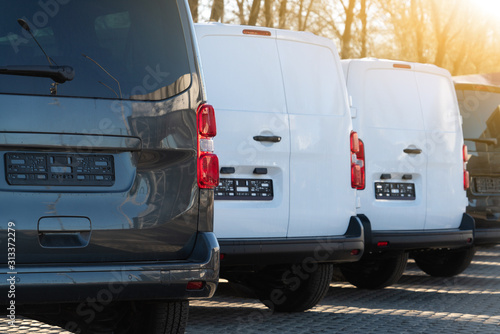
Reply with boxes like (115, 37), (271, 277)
(0, 246), (500, 334)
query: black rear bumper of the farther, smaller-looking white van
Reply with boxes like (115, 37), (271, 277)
(360, 213), (475, 252)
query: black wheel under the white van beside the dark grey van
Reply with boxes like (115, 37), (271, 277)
(237, 263), (333, 312)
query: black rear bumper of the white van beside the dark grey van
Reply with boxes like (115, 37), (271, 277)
(219, 217), (364, 268)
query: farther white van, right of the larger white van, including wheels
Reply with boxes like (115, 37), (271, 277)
(341, 59), (474, 288)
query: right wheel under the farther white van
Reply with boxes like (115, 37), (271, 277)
(412, 247), (476, 277)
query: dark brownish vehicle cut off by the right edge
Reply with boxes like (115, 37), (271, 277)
(454, 76), (500, 245)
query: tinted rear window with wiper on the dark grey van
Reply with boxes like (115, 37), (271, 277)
(0, 0), (191, 100)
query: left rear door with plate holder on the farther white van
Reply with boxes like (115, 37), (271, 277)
(347, 61), (427, 230)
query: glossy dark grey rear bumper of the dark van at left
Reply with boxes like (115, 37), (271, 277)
(0, 233), (220, 305)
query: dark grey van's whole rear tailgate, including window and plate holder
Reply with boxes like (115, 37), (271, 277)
(0, 0), (203, 264)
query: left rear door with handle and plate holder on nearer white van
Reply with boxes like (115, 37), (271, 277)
(195, 25), (290, 238)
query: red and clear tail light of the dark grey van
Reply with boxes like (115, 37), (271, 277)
(197, 104), (219, 189)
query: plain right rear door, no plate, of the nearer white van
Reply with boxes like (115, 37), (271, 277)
(277, 36), (355, 237)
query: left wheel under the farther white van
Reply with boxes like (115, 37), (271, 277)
(339, 252), (408, 289)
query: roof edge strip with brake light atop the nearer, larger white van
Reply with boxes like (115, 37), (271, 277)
(194, 22), (337, 50)
